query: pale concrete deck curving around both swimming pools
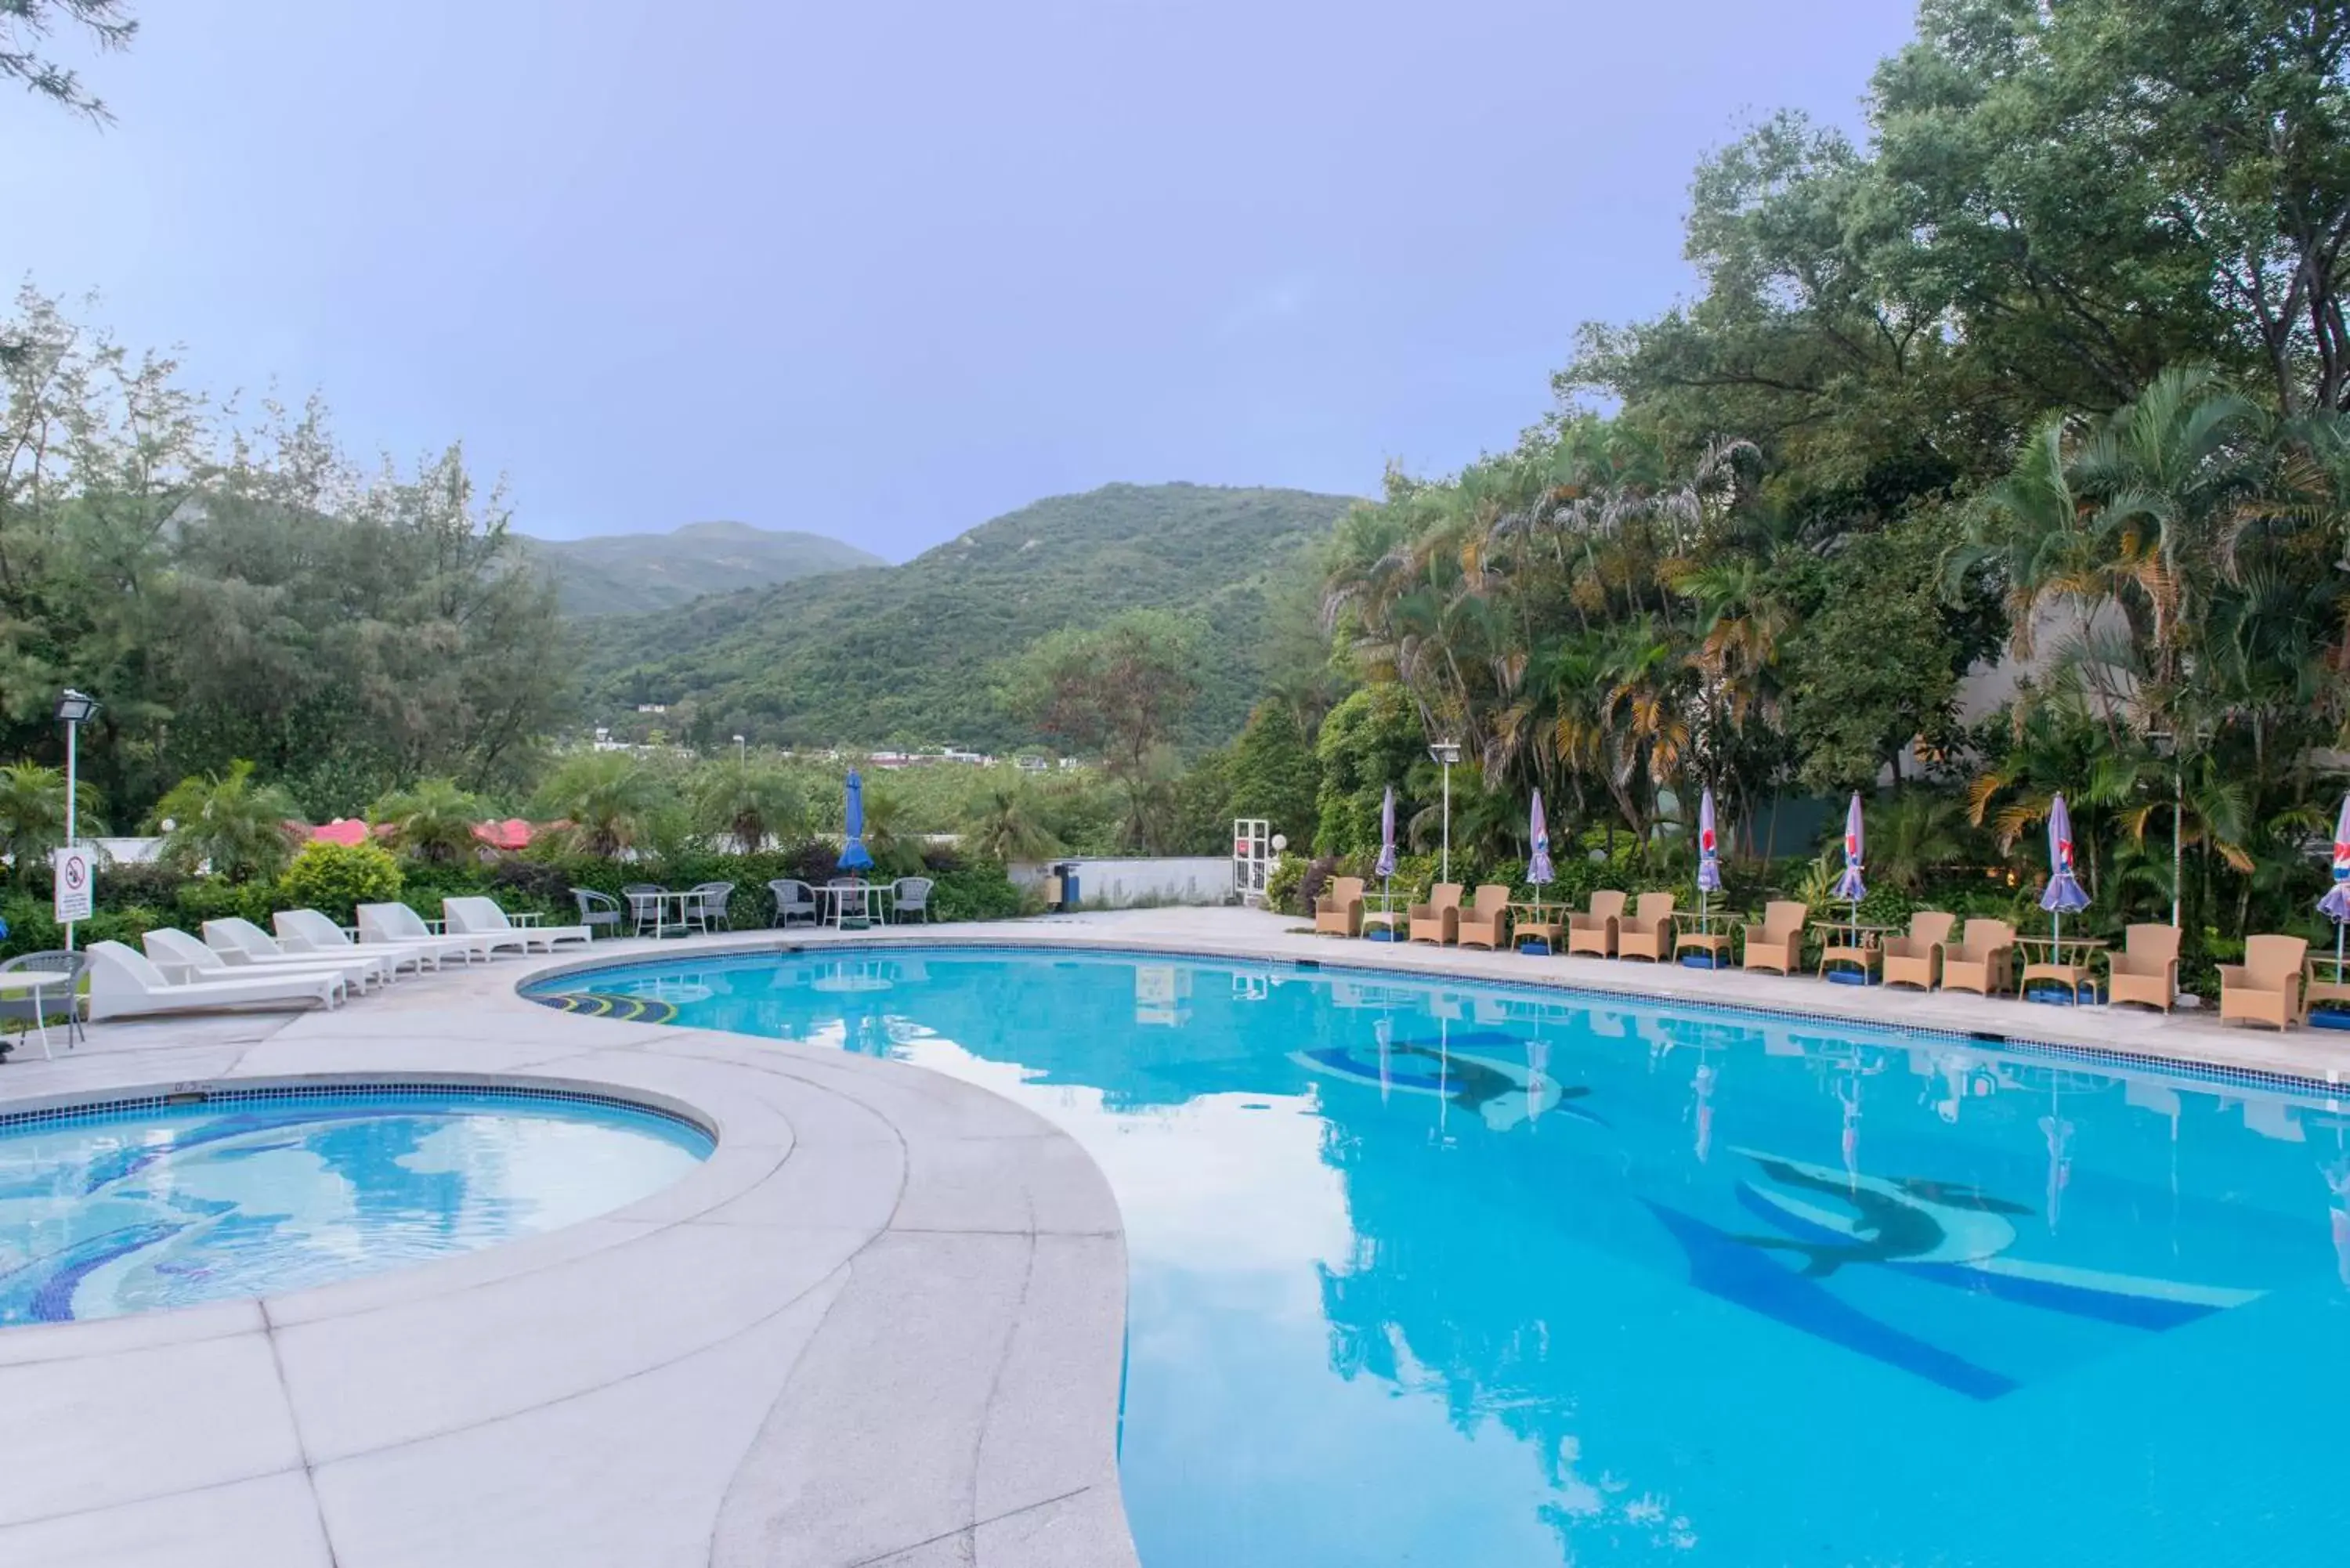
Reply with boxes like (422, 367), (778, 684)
(0, 910), (2350, 1568)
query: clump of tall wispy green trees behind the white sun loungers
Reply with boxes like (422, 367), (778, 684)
(0, 287), (573, 816)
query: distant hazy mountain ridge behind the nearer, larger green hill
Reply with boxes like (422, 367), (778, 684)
(524, 522), (886, 616)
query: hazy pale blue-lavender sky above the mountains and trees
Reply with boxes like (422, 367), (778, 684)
(13, 0), (1911, 557)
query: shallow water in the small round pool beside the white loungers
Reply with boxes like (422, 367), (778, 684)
(0, 1091), (710, 1324)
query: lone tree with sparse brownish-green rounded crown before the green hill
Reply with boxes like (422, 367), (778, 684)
(1001, 609), (1198, 851)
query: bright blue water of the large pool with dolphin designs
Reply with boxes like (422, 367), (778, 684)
(540, 950), (2350, 1568)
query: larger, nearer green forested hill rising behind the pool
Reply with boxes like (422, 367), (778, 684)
(588, 484), (1354, 750)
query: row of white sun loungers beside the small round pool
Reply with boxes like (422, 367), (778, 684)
(89, 898), (590, 1023)
